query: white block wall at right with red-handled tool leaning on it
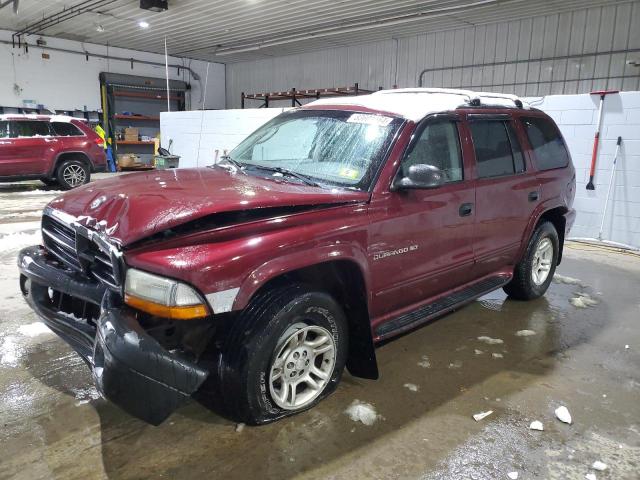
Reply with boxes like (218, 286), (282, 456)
(528, 92), (640, 248)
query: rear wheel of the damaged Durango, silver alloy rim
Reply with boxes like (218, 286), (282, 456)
(504, 222), (560, 300)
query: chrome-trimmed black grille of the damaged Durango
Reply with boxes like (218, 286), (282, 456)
(42, 214), (120, 289)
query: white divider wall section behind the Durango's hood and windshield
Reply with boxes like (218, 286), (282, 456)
(160, 108), (287, 168)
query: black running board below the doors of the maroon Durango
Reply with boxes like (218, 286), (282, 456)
(376, 275), (511, 339)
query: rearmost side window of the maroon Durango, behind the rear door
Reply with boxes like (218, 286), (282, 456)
(522, 117), (569, 170)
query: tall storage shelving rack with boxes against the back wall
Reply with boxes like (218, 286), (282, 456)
(100, 72), (188, 165)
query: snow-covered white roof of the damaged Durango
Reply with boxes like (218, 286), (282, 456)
(307, 88), (531, 122)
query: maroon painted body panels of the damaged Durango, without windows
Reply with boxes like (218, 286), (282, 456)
(43, 106), (574, 338)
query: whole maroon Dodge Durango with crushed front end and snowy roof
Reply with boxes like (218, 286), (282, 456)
(18, 89), (575, 424)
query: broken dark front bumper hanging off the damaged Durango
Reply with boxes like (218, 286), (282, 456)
(18, 246), (209, 425)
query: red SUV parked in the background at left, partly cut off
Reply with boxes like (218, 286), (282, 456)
(0, 114), (107, 190)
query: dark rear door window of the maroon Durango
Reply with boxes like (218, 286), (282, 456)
(469, 120), (524, 178)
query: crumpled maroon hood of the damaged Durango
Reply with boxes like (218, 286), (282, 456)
(49, 168), (369, 246)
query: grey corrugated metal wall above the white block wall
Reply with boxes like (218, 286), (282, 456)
(227, 0), (640, 108)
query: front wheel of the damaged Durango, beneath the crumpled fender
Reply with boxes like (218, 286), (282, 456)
(218, 284), (348, 425)
